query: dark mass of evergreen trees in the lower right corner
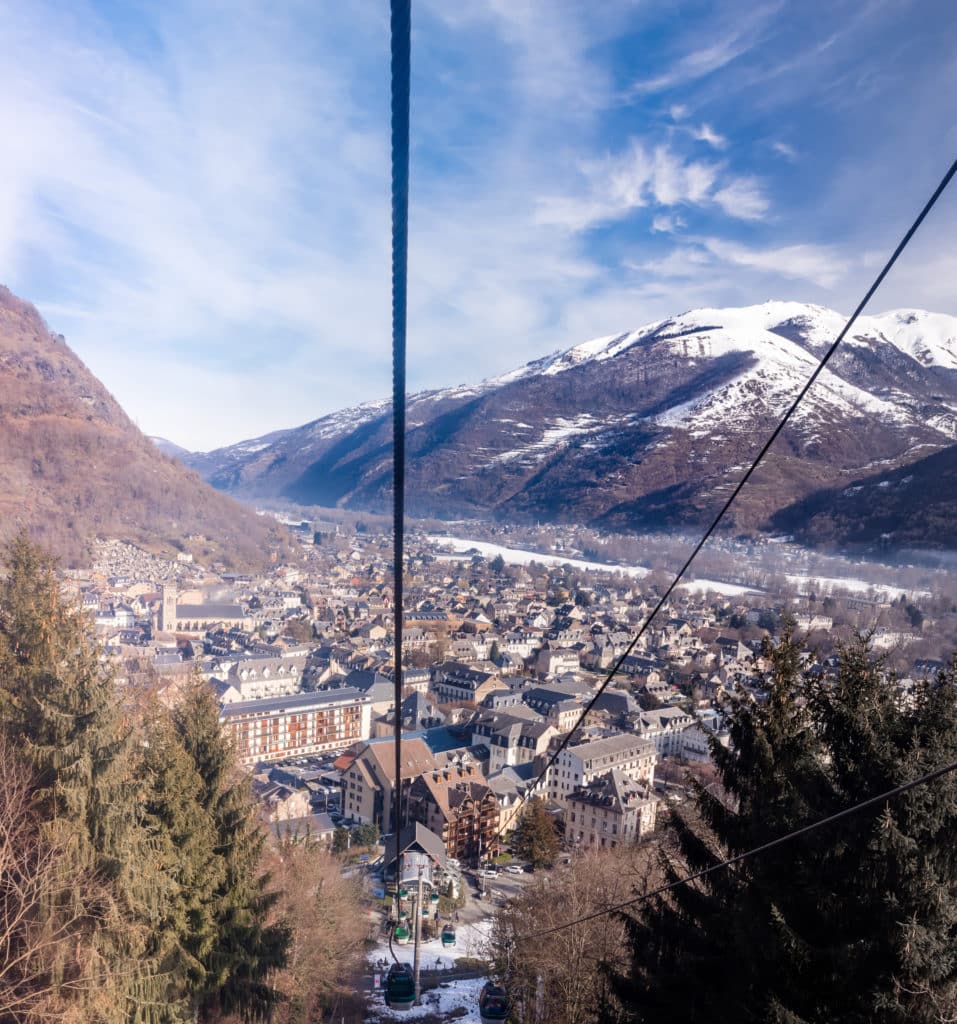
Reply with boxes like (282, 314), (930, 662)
(619, 636), (957, 1024)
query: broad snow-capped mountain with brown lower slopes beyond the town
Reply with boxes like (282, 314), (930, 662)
(186, 302), (957, 548)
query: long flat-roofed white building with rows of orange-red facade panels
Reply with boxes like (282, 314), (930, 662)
(219, 689), (372, 765)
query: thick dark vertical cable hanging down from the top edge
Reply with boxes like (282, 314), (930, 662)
(389, 0), (411, 921)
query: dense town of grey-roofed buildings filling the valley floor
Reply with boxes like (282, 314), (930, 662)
(70, 522), (942, 867)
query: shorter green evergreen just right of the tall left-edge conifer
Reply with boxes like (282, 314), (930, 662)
(174, 680), (291, 1020)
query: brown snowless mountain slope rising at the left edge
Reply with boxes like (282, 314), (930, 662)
(0, 287), (288, 565)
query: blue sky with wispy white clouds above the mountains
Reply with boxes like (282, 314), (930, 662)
(0, 0), (957, 451)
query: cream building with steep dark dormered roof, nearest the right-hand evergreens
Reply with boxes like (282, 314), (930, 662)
(565, 768), (657, 849)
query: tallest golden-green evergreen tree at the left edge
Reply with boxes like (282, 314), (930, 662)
(0, 534), (176, 1024)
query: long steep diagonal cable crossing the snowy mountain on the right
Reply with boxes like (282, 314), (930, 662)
(492, 153), (957, 843)
